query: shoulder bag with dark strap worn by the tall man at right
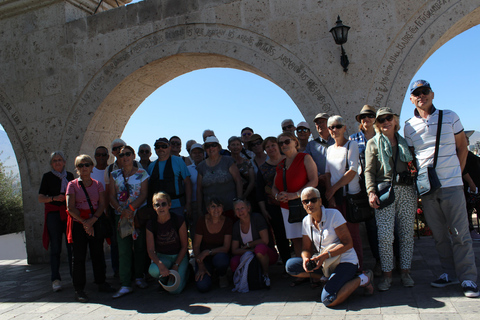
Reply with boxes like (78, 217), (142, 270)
(417, 110), (443, 196)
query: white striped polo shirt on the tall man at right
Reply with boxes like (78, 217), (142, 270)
(404, 107), (463, 188)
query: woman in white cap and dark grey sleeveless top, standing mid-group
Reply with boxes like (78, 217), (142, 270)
(197, 136), (243, 220)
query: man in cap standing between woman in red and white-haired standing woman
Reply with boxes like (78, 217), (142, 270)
(305, 112), (335, 202)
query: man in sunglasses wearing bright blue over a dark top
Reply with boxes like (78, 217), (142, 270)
(147, 138), (192, 217)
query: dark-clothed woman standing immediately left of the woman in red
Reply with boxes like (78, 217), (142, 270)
(256, 137), (290, 265)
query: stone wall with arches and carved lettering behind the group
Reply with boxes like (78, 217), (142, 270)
(0, 0), (480, 263)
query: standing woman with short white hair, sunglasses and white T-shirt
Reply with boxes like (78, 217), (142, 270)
(325, 115), (363, 269)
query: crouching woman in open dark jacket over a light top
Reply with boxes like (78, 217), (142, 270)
(230, 199), (278, 287)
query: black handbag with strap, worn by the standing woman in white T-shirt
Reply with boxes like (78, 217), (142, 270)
(345, 141), (375, 223)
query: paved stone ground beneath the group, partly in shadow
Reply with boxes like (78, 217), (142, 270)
(0, 237), (480, 320)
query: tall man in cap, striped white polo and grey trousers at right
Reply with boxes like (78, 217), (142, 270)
(404, 80), (479, 298)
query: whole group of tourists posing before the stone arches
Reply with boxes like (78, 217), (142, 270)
(39, 80), (479, 307)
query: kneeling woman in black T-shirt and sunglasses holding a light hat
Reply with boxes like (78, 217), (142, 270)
(147, 192), (188, 294)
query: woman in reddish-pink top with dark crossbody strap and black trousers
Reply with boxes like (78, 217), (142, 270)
(66, 154), (115, 302)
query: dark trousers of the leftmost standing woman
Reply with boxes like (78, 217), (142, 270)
(47, 211), (72, 282)
